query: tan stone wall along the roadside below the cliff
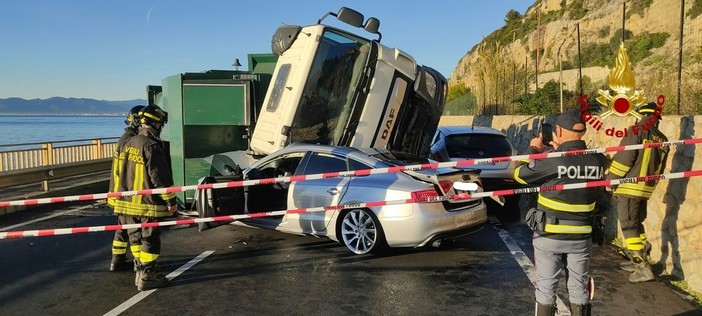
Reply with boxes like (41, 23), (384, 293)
(439, 116), (702, 292)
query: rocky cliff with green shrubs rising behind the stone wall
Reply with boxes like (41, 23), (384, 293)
(449, 0), (702, 111)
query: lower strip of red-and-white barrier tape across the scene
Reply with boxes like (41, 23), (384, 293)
(0, 170), (702, 239)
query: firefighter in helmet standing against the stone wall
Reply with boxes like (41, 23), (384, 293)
(607, 102), (670, 283)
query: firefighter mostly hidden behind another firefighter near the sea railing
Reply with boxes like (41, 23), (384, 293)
(107, 105), (144, 272)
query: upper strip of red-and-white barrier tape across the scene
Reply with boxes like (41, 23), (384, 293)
(0, 138), (702, 207)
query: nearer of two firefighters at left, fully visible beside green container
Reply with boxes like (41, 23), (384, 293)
(113, 105), (178, 291)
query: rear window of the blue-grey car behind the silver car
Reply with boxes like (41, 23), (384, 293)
(446, 133), (512, 158)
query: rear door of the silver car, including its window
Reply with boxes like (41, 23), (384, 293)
(288, 153), (350, 235)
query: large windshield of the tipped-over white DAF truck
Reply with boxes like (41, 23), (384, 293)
(289, 29), (370, 145)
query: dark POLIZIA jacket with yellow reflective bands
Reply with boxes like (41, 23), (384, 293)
(514, 140), (606, 239)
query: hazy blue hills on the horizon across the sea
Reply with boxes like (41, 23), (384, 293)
(0, 97), (146, 115)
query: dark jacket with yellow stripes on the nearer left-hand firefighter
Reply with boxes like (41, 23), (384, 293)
(112, 127), (176, 217)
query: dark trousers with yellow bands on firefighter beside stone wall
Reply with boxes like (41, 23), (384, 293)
(617, 196), (648, 251)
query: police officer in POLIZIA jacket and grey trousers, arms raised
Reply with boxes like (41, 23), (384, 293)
(514, 109), (605, 315)
